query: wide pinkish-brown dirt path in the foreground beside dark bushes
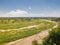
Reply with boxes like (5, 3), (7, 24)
(6, 21), (58, 45)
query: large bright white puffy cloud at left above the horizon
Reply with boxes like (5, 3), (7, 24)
(0, 10), (28, 17)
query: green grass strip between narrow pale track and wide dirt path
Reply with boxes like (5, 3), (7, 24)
(0, 20), (55, 45)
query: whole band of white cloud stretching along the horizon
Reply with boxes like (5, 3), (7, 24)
(0, 10), (60, 17)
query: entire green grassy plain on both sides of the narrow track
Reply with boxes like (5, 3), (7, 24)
(0, 19), (55, 45)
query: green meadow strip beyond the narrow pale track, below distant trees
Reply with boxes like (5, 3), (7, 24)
(0, 19), (42, 30)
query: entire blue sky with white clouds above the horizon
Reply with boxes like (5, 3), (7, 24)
(0, 0), (60, 17)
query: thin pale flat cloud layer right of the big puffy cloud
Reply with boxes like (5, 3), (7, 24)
(28, 11), (60, 17)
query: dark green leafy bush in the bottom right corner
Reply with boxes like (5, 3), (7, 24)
(43, 28), (60, 45)
